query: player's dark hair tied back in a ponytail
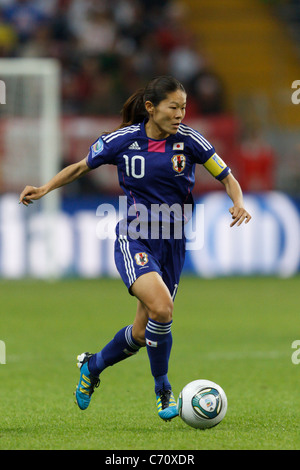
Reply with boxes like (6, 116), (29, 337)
(118, 75), (185, 129)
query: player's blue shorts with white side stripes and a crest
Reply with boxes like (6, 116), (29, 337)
(115, 222), (185, 299)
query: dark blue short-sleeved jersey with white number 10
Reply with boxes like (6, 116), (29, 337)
(87, 122), (230, 222)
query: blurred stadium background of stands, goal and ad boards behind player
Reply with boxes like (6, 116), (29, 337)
(0, 0), (300, 279)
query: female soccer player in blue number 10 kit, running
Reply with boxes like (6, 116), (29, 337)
(20, 76), (251, 421)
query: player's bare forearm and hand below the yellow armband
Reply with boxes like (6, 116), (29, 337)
(221, 173), (251, 227)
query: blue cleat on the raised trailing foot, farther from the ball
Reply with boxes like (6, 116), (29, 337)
(75, 352), (100, 410)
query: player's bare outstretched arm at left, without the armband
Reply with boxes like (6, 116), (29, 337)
(19, 158), (91, 206)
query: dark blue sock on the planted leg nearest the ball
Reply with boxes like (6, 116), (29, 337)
(145, 318), (172, 394)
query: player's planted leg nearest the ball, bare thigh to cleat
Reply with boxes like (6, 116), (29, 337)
(131, 272), (178, 420)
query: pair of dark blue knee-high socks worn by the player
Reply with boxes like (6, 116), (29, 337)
(88, 319), (172, 394)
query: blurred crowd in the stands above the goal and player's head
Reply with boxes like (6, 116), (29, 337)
(0, 0), (224, 116)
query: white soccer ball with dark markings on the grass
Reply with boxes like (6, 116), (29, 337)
(177, 380), (227, 429)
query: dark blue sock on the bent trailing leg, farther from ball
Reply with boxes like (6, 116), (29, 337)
(88, 325), (141, 377)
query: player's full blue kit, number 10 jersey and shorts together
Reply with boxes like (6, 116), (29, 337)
(87, 118), (230, 299)
